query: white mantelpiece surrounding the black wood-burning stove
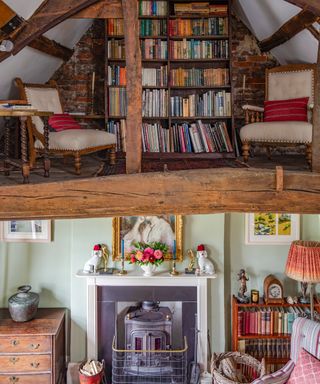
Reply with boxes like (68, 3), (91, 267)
(77, 270), (216, 380)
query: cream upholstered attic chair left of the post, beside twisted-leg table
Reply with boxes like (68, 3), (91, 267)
(15, 78), (116, 174)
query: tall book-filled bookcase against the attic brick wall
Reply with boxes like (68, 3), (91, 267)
(105, 0), (236, 158)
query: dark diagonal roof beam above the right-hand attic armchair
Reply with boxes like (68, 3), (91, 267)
(259, 9), (319, 52)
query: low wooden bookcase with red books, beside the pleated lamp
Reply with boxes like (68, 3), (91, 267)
(232, 296), (320, 372)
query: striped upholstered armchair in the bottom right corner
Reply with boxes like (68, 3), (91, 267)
(252, 318), (320, 384)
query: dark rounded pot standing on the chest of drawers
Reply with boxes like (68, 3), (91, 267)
(8, 285), (39, 322)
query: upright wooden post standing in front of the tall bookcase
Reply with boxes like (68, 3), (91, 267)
(122, 0), (142, 173)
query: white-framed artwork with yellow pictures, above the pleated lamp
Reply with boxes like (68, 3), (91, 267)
(245, 212), (300, 245)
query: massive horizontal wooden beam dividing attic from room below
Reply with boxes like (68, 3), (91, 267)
(0, 168), (320, 220)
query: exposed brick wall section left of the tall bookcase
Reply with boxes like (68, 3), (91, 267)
(52, 20), (104, 114)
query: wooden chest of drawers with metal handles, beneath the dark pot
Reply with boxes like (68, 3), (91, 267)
(0, 308), (65, 384)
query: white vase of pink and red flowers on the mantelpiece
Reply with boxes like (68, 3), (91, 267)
(130, 242), (168, 276)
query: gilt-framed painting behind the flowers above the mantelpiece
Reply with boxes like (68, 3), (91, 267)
(112, 215), (183, 261)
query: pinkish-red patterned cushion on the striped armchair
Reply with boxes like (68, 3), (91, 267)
(287, 348), (320, 384)
